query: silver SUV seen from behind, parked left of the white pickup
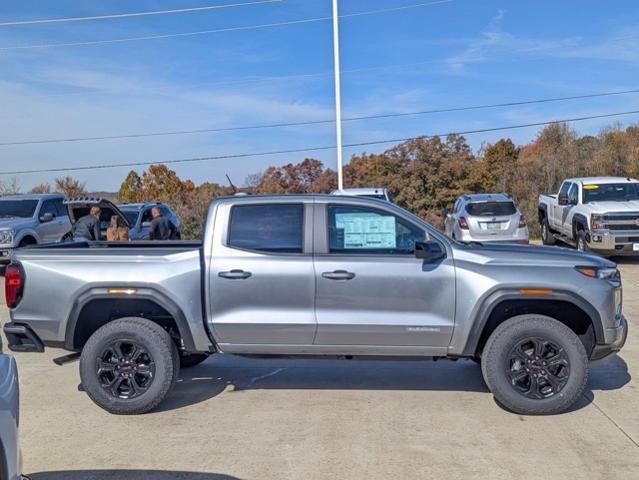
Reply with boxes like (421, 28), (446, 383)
(443, 193), (528, 243)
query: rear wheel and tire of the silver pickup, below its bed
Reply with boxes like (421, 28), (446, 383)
(80, 317), (180, 415)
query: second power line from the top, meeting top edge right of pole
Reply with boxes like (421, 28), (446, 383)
(0, 0), (453, 51)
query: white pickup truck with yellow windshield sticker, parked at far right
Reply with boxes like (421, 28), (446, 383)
(539, 177), (639, 255)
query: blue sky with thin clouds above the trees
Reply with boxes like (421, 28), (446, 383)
(0, 0), (639, 190)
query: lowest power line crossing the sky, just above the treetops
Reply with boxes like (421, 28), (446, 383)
(0, 110), (639, 175)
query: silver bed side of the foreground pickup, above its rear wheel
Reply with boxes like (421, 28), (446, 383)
(12, 241), (211, 351)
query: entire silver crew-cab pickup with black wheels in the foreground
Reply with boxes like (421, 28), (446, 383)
(4, 195), (628, 414)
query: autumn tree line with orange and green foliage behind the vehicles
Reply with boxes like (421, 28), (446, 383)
(5, 124), (639, 238)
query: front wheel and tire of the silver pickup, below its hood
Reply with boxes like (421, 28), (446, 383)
(481, 314), (588, 415)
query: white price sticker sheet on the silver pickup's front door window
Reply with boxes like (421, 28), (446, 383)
(335, 212), (397, 249)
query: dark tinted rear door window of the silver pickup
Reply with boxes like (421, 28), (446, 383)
(227, 203), (304, 253)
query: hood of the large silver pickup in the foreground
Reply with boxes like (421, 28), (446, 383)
(455, 244), (616, 268)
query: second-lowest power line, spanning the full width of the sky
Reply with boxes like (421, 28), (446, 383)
(5, 89), (639, 147)
